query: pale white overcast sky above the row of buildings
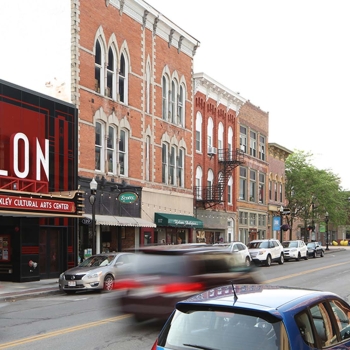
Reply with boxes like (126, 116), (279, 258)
(0, 0), (350, 190)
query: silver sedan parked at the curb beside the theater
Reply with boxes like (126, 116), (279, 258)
(59, 253), (134, 294)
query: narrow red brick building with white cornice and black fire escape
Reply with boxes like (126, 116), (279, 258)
(193, 73), (246, 243)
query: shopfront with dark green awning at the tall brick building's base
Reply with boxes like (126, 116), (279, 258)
(154, 213), (203, 244)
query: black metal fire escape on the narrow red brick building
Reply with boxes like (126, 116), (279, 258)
(194, 147), (244, 208)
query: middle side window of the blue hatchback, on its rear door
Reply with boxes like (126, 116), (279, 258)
(310, 303), (337, 347)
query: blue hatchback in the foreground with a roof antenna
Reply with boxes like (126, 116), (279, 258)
(152, 285), (350, 350)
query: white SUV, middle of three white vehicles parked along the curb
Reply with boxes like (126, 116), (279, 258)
(248, 239), (284, 266)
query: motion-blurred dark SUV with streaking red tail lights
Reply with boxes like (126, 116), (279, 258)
(115, 244), (260, 321)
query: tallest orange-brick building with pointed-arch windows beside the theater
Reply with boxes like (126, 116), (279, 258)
(71, 0), (202, 254)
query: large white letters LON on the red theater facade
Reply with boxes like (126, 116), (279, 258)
(0, 132), (49, 181)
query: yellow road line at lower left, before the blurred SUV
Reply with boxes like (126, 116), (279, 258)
(0, 314), (131, 349)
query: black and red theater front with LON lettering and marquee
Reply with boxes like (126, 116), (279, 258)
(0, 80), (84, 282)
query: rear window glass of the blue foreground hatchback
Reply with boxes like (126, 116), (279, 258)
(158, 309), (288, 350)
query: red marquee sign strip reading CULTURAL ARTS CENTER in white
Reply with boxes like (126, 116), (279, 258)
(0, 195), (75, 213)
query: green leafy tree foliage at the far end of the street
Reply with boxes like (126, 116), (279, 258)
(285, 151), (349, 230)
